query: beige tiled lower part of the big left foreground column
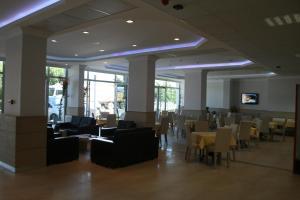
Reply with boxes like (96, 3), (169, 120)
(0, 115), (47, 172)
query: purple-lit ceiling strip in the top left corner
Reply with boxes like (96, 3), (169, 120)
(0, 0), (61, 28)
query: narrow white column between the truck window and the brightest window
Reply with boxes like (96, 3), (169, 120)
(67, 64), (86, 116)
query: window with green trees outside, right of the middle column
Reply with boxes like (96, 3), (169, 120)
(154, 80), (181, 115)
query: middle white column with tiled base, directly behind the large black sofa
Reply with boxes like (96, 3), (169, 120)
(126, 55), (157, 126)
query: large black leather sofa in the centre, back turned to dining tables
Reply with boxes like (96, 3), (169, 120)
(91, 128), (158, 168)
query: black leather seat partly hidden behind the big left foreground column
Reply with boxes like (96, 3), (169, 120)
(47, 127), (79, 165)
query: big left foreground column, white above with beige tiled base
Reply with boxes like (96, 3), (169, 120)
(0, 29), (47, 172)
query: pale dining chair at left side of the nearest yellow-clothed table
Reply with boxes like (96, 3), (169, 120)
(185, 125), (199, 161)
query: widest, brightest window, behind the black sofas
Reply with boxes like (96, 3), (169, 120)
(84, 71), (127, 119)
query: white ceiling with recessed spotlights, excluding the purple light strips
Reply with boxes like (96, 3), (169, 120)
(0, 0), (300, 77)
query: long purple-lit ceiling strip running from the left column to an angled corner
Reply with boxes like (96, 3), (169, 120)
(47, 37), (207, 61)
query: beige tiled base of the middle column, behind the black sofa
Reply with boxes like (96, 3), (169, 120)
(125, 111), (155, 128)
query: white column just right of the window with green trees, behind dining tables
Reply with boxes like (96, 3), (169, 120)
(184, 70), (207, 117)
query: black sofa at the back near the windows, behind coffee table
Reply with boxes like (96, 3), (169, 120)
(54, 116), (99, 136)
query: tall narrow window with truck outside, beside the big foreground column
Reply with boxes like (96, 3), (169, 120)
(46, 66), (67, 123)
